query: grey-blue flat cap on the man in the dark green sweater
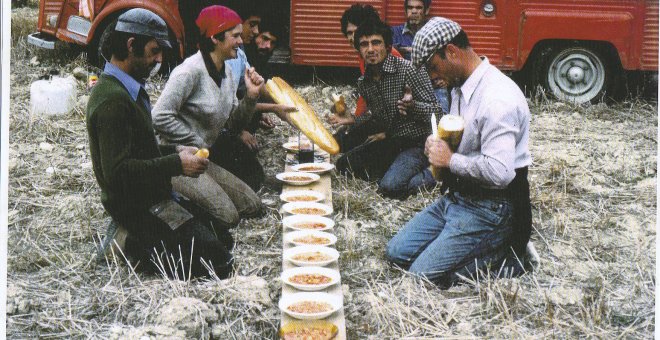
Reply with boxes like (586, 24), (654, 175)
(115, 8), (172, 48)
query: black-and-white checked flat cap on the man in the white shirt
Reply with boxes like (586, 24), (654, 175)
(412, 17), (461, 68)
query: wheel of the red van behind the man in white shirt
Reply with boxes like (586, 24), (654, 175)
(534, 47), (612, 104)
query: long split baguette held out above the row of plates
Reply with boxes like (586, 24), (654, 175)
(266, 77), (339, 155)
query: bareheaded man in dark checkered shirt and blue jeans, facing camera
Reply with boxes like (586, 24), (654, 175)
(337, 20), (440, 197)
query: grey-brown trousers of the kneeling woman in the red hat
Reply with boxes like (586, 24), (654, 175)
(172, 162), (262, 228)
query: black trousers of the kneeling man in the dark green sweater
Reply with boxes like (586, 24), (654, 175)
(115, 200), (234, 280)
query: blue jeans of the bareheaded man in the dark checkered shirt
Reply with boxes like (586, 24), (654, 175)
(378, 147), (436, 197)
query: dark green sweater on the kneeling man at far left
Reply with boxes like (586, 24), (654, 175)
(87, 74), (183, 223)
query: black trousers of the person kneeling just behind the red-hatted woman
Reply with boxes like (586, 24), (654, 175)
(209, 130), (265, 192)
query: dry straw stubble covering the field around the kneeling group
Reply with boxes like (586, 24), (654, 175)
(7, 10), (657, 339)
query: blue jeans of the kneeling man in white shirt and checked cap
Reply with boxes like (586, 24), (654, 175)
(387, 193), (517, 286)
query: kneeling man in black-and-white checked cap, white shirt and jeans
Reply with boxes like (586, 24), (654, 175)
(387, 17), (532, 287)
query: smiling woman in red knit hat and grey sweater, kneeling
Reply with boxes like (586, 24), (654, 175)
(152, 5), (264, 234)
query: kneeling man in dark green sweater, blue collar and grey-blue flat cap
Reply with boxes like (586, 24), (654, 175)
(86, 9), (233, 279)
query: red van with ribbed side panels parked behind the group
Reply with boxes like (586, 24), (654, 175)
(28, 0), (658, 102)
